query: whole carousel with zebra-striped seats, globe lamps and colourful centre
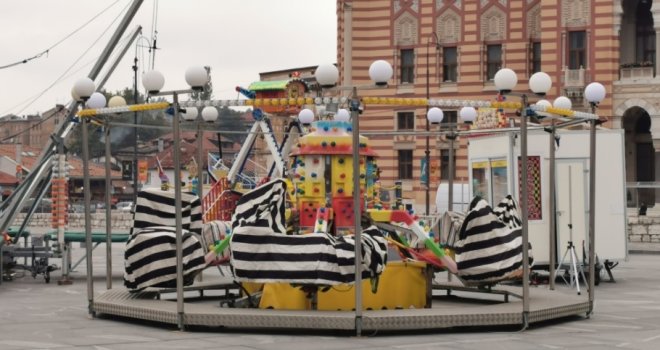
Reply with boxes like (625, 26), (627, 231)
(0, 2), (605, 335)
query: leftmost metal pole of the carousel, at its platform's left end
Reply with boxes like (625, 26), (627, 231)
(80, 117), (95, 317)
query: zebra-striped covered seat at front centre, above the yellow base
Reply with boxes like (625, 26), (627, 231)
(230, 179), (387, 285)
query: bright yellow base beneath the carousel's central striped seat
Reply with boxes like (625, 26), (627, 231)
(259, 261), (431, 311)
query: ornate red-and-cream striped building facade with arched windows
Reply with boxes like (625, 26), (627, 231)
(337, 0), (660, 212)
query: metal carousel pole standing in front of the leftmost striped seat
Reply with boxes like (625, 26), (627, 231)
(172, 91), (185, 330)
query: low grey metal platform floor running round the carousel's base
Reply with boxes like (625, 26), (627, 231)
(92, 285), (589, 331)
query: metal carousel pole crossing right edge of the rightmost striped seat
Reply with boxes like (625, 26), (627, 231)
(519, 95), (529, 329)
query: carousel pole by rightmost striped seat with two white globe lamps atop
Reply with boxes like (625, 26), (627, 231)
(494, 68), (552, 328)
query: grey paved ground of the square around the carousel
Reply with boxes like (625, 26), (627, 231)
(0, 244), (660, 350)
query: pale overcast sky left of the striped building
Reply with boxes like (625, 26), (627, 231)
(0, 0), (337, 116)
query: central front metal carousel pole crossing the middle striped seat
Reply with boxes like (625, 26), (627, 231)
(350, 87), (362, 337)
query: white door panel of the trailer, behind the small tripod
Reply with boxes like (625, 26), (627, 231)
(556, 159), (588, 263)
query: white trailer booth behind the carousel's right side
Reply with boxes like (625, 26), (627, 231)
(468, 128), (628, 266)
